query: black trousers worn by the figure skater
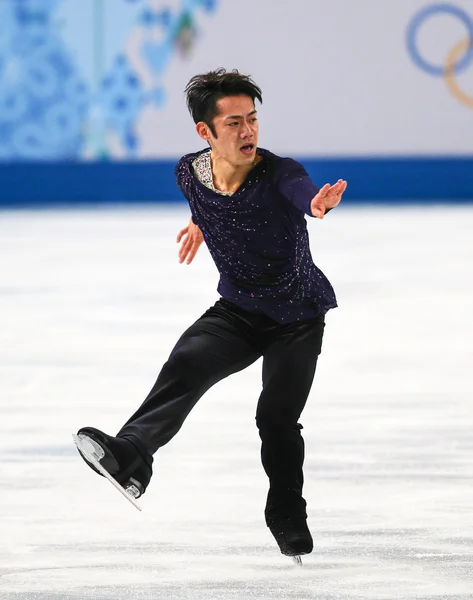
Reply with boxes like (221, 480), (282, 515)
(117, 300), (324, 524)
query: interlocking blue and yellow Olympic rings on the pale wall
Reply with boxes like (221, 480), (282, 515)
(406, 4), (473, 108)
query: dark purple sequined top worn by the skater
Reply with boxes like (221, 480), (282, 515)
(175, 148), (337, 323)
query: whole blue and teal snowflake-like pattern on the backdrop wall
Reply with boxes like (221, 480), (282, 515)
(0, 0), (217, 161)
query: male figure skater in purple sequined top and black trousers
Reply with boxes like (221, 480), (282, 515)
(78, 69), (347, 556)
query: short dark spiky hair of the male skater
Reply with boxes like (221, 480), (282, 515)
(184, 68), (263, 136)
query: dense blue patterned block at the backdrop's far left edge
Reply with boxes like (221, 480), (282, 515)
(0, 0), (88, 159)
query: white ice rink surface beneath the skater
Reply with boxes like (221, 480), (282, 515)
(0, 206), (473, 600)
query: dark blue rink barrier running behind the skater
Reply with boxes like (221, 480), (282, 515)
(0, 155), (473, 207)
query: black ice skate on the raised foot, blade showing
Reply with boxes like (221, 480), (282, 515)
(72, 427), (151, 510)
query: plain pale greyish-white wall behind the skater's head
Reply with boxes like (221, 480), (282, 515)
(132, 0), (473, 156)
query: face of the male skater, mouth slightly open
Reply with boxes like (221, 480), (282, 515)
(197, 95), (258, 167)
